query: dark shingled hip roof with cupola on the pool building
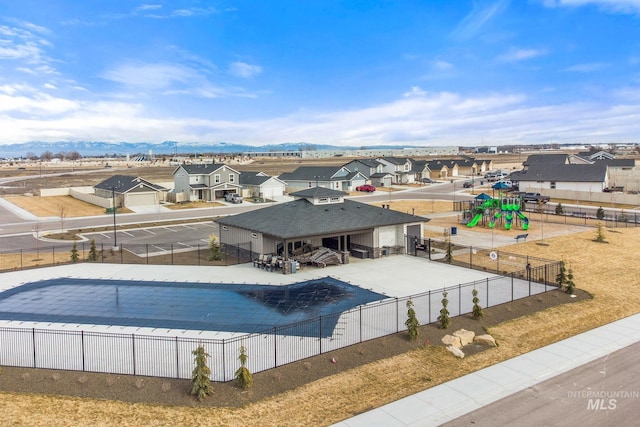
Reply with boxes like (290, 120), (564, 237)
(216, 198), (428, 239)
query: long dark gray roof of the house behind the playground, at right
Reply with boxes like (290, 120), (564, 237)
(511, 162), (607, 182)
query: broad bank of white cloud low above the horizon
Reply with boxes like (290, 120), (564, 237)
(0, 85), (640, 146)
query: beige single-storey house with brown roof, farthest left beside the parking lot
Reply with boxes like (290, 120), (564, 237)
(93, 175), (167, 207)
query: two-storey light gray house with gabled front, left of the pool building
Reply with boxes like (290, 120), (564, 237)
(173, 163), (242, 202)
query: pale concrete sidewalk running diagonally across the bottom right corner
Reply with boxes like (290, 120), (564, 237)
(335, 314), (640, 427)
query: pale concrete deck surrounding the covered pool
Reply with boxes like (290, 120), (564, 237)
(0, 255), (495, 338)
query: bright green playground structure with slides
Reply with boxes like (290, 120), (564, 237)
(465, 195), (529, 230)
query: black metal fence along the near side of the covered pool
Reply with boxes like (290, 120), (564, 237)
(0, 262), (560, 382)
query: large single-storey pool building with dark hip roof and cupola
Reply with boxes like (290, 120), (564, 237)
(216, 187), (428, 259)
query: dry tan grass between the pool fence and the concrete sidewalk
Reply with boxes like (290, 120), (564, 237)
(0, 228), (640, 426)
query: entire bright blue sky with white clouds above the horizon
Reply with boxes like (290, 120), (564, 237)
(0, 0), (640, 147)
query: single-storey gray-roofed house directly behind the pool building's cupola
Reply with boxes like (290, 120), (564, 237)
(278, 166), (367, 193)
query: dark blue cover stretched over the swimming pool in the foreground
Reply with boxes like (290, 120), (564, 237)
(0, 277), (387, 337)
